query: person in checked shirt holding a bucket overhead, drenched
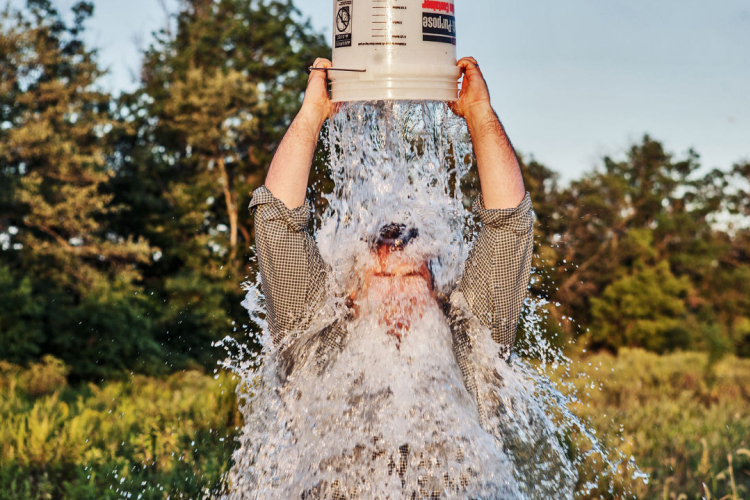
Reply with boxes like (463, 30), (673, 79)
(250, 57), (534, 498)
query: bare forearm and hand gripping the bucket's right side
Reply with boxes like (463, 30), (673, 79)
(451, 57), (526, 210)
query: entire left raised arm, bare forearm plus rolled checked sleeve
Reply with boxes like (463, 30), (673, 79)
(250, 59), (334, 344)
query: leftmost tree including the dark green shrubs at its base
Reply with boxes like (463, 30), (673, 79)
(0, 0), (160, 376)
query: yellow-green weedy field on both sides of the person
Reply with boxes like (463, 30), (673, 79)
(0, 350), (750, 500)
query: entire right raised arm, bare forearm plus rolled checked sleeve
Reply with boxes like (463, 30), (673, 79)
(452, 58), (534, 356)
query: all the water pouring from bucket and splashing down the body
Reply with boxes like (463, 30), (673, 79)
(213, 103), (648, 500)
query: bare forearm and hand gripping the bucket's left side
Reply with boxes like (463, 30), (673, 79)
(265, 59), (335, 210)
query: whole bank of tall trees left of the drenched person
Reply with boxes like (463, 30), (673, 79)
(0, 0), (329, 379)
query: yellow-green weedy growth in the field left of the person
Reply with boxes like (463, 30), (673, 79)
(0, 359), (241, 499)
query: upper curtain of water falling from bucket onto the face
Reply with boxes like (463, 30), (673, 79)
(316, 102), (472, 293)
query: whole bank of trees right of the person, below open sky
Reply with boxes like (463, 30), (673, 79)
(525, 136), (750, 356)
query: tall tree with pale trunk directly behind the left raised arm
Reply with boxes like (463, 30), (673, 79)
(106, 0), (330, 363)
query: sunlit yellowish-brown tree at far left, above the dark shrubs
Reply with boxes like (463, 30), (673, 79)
(0, 0), (150, 292)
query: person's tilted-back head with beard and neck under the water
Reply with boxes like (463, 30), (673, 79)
(352, 224), (435, 340)
